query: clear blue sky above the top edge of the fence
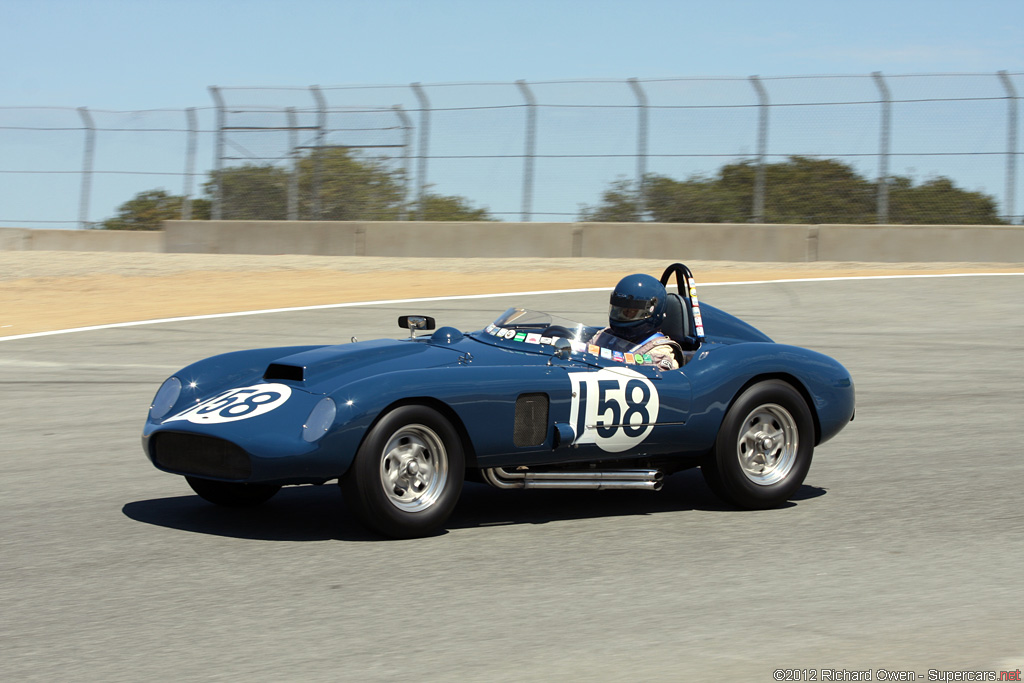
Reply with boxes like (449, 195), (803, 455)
(6, 0), (1024, 110)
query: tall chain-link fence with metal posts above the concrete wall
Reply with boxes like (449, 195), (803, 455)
(0, 72), (1024, 227)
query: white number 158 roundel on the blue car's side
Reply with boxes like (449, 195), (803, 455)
(569, 368), (659, 453)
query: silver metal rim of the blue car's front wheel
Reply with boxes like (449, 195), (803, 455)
(380, 425), (447, 512)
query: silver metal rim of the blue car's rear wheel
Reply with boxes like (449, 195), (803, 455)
(736, 403), (800, 486)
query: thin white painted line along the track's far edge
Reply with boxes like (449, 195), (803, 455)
(0, 272), (1024, 342)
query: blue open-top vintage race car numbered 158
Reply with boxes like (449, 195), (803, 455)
(142, 263), (854, 538)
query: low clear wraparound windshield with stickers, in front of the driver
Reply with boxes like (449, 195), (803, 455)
(483, 308), (653, 366)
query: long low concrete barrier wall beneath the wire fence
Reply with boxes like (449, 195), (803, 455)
(0, 220), (1024, 263)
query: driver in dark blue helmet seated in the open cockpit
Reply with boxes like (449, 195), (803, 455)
(591, 273), (683, 370)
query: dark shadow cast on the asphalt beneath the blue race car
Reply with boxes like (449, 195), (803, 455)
(122, 470), (825, 542)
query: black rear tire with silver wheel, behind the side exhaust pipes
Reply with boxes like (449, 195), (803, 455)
(700, 380), (814, 510)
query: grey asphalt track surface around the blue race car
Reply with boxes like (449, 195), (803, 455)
(0, 275), (1024, 681)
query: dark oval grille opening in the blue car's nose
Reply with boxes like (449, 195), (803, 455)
(151, 432), (252, 479)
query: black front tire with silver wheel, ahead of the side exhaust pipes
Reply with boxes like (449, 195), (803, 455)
(341, 405), (466, 539)
